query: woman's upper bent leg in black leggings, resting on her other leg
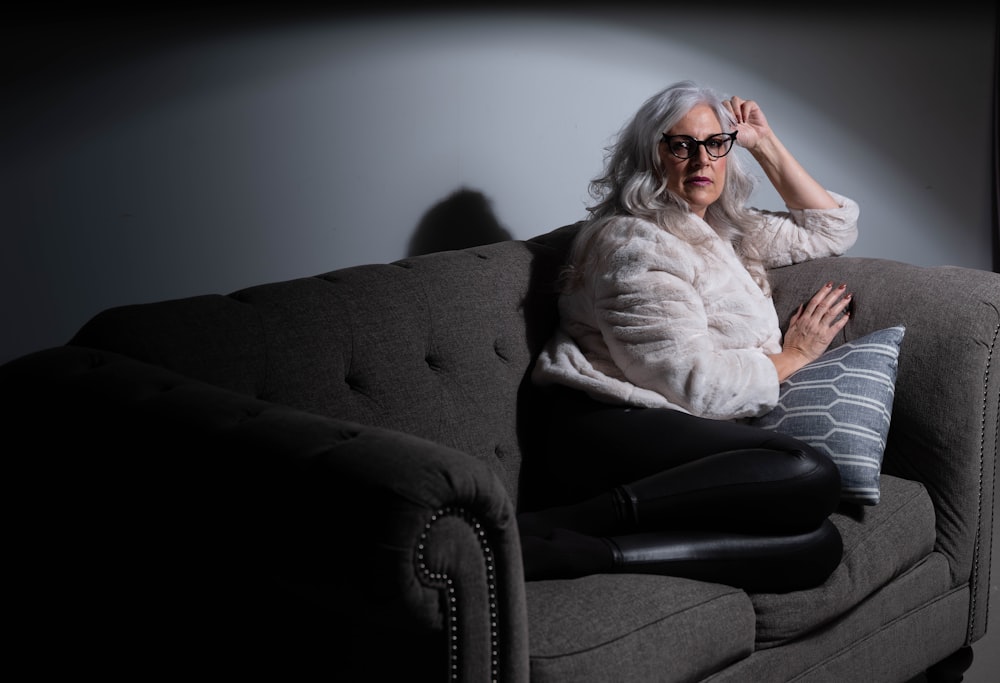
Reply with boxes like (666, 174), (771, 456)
(519, 390), (840, 537)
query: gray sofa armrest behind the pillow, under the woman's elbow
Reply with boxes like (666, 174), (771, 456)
(771, 257), (1000, 641)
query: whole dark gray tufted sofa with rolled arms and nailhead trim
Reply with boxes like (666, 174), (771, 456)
(0, 226), (1000, 683)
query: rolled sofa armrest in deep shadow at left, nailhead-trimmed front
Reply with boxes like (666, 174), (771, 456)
(0, 346), (528, 681)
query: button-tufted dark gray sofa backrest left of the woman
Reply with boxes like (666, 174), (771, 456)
(70, 229), (569, 501)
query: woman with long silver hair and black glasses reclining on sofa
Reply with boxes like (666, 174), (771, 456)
(518, 81), (858, 592)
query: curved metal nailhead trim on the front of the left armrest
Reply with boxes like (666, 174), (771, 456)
(417, 507), (500, 683)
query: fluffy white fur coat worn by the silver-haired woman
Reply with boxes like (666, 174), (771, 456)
(533, 193), (859, 419)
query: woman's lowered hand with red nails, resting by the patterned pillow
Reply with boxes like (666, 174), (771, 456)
(770, 282), (851, 382)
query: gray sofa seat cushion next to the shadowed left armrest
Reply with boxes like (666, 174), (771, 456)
(526, 574), (754, 683)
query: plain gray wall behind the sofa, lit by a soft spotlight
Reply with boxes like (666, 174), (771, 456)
(0, 0), (1000, 683)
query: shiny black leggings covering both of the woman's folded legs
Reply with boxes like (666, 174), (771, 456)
(519, 389), (841, 590)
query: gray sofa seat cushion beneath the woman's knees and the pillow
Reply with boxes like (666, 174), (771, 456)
(751, 475), (935, 649)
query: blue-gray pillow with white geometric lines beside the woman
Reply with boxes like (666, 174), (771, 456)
(751, 326), (906, 505)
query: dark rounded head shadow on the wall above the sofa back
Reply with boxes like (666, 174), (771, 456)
(407, 187), (511, 256)
